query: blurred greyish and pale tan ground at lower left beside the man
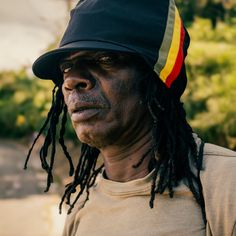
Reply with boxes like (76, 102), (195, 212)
(0, 139), (66, 236)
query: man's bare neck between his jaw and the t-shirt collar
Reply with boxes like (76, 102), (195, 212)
(100, 130), (153, 182)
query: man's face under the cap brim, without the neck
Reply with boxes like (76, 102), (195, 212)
(60, 51), (150, 149)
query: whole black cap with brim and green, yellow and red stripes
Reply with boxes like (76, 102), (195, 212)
(33, 0), (190, 96)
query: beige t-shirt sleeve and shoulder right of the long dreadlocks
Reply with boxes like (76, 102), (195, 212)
(201, 144), (236, 236)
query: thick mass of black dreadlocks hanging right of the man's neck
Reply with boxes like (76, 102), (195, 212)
(142, 71), (206, 223)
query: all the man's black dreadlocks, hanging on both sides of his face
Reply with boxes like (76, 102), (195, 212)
(24, 53), (206, 222)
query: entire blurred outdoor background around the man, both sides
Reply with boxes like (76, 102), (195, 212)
(0, 0), (236, 236)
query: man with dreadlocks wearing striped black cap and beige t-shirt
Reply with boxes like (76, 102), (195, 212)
(24, 0), (236, 236)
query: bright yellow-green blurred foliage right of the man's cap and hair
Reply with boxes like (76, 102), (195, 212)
(184, 19), (236, 149)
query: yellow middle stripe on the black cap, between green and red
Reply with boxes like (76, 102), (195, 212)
(159, 7), (181, 83)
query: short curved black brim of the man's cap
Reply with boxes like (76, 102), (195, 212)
(32, 41), (135, 82)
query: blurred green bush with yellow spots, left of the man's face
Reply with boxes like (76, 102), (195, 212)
(0, 69), (52, 137)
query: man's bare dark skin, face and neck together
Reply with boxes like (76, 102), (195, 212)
(61, 51), (153, 182)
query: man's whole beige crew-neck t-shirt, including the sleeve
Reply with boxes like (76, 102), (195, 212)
(63, 144), (236, 236)
